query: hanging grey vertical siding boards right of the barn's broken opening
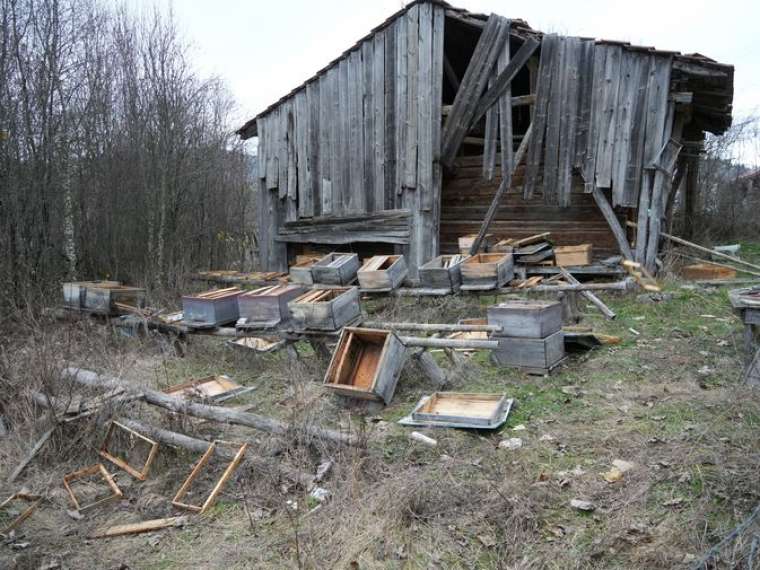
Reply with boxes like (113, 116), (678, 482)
(524, 34), (672, 207)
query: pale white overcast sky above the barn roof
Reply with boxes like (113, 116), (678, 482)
(126, 0), (760, 158)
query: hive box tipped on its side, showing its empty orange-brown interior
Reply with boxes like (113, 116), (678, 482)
(324, 327), (405, 404)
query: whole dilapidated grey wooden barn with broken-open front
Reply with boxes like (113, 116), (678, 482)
(238, 0), (733, 275)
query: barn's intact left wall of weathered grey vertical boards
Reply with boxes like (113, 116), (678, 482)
(257, 3), (444, 270)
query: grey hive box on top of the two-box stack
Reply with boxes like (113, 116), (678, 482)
(487, 300), (562, 338)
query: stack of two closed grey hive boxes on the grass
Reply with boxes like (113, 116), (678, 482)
(488, 300), (565, 375)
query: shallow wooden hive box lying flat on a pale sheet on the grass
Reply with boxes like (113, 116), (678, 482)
(411, 392), (510, 428)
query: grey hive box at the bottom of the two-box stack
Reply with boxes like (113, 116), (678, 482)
(492, 331), (565, 374)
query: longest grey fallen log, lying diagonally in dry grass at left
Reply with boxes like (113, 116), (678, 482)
(62, 367), (357, 445)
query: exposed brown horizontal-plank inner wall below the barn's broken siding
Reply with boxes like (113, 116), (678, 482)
(440, 156), (625, 256)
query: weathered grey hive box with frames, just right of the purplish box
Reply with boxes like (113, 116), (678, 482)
(288, 287), (361, 331)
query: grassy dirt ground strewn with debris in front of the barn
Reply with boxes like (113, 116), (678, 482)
(0, 268), (760, 569)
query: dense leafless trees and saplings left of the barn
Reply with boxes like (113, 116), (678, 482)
(0, 0), (253, 306)
